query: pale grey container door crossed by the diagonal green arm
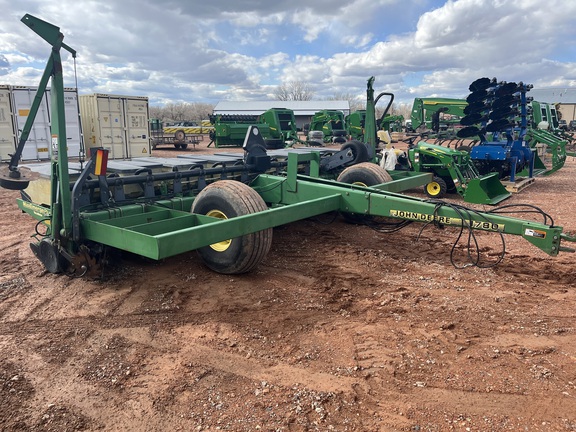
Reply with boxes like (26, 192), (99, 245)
(12, 87), (52, 160)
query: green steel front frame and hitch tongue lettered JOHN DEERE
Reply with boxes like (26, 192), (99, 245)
(62, 150), (574, 259)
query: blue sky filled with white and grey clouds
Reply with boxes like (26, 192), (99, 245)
(0, 0), (576, 106)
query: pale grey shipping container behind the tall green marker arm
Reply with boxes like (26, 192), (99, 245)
(0, 86), (81, 161)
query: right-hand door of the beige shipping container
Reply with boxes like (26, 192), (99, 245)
(124, 98), (150, 158)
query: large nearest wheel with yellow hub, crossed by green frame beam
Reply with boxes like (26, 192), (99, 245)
(191, 180), (272, 274)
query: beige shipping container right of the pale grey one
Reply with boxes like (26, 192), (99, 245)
(80, 93), (150, 159)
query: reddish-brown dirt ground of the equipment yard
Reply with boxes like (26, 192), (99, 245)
(0, 142), (576, 431)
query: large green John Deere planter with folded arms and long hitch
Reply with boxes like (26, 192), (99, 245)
(0, 15), (576, 276)
